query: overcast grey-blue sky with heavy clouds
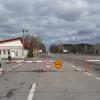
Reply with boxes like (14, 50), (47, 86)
(0, 0), (100, 44)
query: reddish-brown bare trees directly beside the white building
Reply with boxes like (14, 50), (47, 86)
(21, 35), (46, 57)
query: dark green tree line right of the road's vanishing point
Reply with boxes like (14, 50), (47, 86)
(49, 43), (94, 54)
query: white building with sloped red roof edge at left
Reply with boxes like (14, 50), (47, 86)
(0, 38), (28, 58)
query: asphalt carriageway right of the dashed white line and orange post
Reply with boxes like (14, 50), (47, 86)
(50, 54), (100, 77)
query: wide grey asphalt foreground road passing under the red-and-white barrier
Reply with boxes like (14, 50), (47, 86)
(0, 56), (100, 100)
